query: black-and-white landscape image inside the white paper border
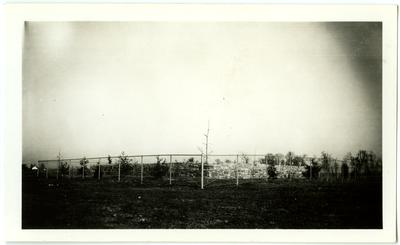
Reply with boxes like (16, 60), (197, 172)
(2, 2), (395, 244)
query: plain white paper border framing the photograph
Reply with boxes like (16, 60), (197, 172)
(4, 4), (397, 243)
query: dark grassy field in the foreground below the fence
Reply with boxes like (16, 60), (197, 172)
(22, 177), (382, 229)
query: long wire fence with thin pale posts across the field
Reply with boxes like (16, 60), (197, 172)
(31, 154), (382, 189)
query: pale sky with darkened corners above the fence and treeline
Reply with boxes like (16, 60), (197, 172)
(22, 22), (382, 163)
